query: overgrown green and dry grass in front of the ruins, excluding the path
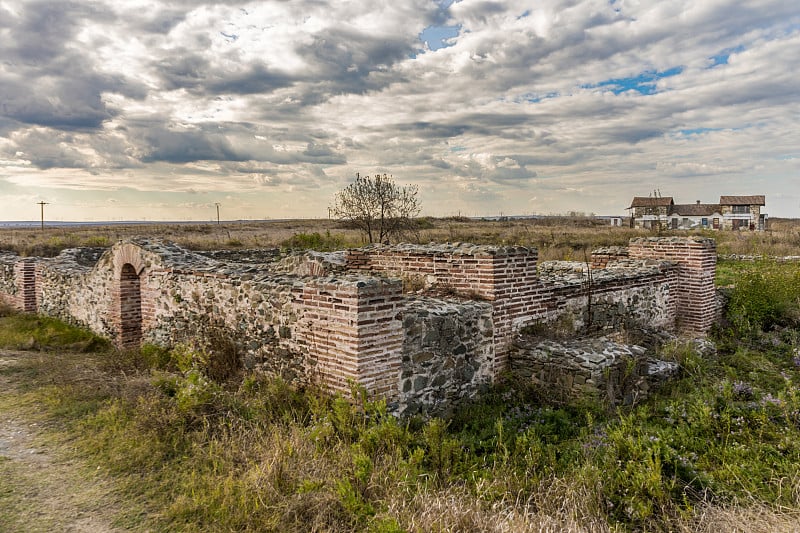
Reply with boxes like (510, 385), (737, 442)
(0, 256), (800, 531)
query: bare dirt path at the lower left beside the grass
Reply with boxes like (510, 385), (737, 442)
(0, 351), (122, 533)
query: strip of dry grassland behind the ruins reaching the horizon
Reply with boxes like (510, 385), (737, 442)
(0, 217), (800, 261)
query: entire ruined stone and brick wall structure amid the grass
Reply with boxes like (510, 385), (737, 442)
(0, 237), (716, 414)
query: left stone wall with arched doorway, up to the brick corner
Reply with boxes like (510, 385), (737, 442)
(22, 240), (403, 400)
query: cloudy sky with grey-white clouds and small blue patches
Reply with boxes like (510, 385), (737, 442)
(0, 0), (800, 220)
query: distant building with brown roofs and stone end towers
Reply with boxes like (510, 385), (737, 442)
(628, 195), (767, 231)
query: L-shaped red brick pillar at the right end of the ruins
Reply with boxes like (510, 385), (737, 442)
(629, 237), (717, 335)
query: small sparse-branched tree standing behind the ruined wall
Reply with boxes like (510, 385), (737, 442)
(330, 174), (420, 242)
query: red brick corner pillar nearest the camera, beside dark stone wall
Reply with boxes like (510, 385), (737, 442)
(297, 279), (403, 399)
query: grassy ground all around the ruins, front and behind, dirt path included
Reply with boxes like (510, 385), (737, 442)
(0, 218), (800, 533)
